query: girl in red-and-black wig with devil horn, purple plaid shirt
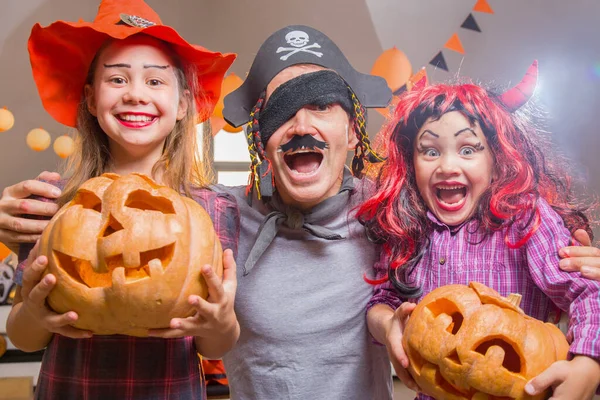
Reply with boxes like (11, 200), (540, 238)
(358, 63), (600, 399)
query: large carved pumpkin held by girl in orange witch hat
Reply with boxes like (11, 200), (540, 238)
(40, 174), (223, 336)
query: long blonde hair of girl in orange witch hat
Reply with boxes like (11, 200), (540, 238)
(58, 34), (212, 206)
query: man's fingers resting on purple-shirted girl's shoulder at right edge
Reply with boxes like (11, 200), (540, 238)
(558, 229), (600, 281)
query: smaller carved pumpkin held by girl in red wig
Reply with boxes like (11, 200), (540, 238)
(402, 282), (569, 400)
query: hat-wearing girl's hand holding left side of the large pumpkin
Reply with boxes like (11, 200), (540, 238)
(21, 244), (92, 339)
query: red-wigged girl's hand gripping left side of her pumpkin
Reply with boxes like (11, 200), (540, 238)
(385, 302), (420, 392)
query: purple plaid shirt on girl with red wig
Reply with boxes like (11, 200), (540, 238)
(368, 199), (600, 399)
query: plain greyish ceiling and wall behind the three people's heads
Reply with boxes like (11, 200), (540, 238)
(0, 0), (600, 234)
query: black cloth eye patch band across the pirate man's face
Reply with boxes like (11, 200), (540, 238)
(258, 71), (352, 147)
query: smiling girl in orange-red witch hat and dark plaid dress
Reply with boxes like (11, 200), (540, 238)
(7, 0), (239, 399)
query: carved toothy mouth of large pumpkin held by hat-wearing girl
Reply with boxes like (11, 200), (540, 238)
(53, 243), (175, 288)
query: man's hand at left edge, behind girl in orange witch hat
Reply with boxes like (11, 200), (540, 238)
(0, 171), (61, 253)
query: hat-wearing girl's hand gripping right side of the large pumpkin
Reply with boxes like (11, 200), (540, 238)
(148, 250), (239, 340)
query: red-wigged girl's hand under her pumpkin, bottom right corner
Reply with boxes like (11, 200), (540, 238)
(525, 356), (600, 400)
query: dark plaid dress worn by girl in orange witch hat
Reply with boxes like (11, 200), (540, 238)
(16, 181), (240, 400)
